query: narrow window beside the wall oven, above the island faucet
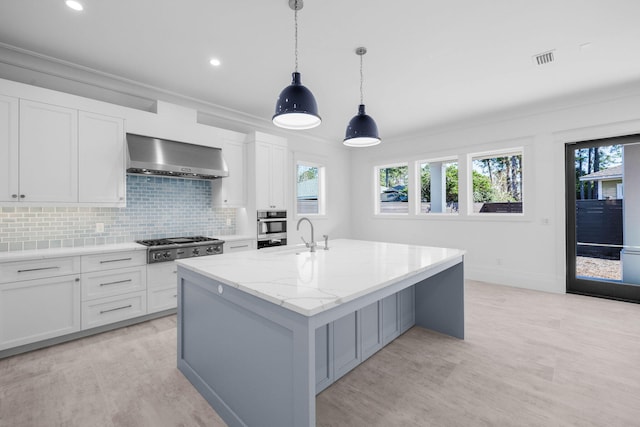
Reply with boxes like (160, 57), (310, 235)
(296, 162), (325, 215)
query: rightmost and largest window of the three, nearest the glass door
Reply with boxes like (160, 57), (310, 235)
(471, 151), (523, 214)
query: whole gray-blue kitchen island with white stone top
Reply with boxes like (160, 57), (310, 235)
(178, 239), (464, 426)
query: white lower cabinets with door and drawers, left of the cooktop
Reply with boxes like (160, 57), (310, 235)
(0, 251), (151, 351)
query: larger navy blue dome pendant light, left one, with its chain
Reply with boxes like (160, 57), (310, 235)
(272, 0), (322, 129)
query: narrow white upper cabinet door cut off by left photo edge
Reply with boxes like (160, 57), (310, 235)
(0, 95), (19, 202)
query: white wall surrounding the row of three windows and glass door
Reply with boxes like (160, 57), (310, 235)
(351, 85), (640, 292)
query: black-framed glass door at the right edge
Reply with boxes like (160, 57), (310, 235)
(565, 135), (640, 302)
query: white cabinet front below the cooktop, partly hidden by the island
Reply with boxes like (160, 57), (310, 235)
(147, 261), (178, 313)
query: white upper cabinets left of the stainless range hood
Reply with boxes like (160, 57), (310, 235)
(0, 95), (126, 206)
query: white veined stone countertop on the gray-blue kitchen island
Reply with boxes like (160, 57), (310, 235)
(177, 239), (465, 316)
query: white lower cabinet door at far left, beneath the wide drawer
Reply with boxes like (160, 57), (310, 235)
(0, 276), (80, 350)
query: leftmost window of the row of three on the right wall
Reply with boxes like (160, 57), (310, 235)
(376, 163), (409, 214)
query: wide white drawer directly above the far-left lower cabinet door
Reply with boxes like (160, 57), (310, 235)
(0, 257), (80, 283)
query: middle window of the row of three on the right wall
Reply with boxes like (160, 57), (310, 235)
(418, 160), (458, 213)
